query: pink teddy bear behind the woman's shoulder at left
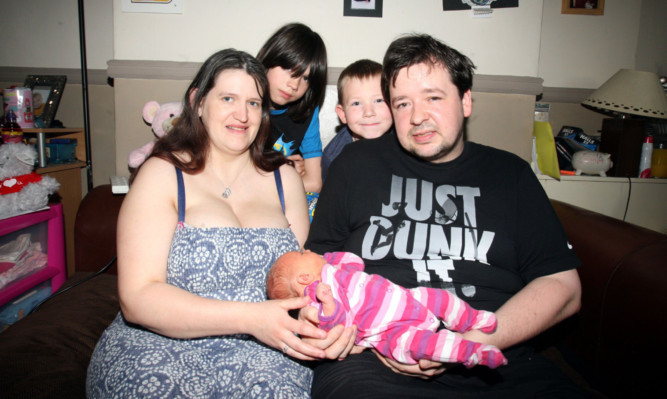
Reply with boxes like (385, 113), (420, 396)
(127, 101), (183, 168)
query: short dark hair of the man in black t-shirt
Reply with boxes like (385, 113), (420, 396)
(382, 34), (475, 104)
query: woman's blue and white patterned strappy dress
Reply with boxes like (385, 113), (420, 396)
(86, 170), (312, 398)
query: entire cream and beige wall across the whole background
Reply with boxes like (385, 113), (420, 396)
(0, 0), (667, 185)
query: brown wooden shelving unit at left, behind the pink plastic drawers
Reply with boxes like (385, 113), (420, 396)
(23, 128), (87, 276)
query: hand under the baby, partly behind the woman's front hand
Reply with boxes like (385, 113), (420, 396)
(299, 306), (363, 360)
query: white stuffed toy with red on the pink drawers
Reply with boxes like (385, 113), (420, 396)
(0, 143), (60, 219)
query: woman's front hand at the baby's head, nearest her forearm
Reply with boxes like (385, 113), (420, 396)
(248, 297), (327, 360)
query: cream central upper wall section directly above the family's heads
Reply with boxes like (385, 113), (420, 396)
(113, 0), (544, 76)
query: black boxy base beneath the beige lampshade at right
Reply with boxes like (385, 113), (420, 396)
(600, 118), (646, 177)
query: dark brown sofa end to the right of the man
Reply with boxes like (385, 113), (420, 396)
(551, 200), (667, 396)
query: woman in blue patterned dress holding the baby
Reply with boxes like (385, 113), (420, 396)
(87, 50), (334, 398)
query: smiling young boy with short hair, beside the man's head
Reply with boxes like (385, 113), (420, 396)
(322, 60), (393, 181)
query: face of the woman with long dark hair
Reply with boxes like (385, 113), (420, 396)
(199, 69), (262, 154)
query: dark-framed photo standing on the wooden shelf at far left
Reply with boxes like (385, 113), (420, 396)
(23, 75), (67, 128)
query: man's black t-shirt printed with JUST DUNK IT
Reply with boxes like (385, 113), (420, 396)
(306, 133), (580, 311)
